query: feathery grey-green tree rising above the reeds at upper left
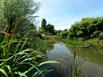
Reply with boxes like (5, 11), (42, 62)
(0, 0), (39, 36)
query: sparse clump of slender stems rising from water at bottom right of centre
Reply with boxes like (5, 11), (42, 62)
(66, 51), (89, 77)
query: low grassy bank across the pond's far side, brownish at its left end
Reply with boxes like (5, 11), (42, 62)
(45, 36), (103, 48)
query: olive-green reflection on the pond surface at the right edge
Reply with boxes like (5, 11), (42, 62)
(70, 46), (103, 66)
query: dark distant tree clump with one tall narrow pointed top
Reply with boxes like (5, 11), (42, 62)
(41, 19), (55, 35)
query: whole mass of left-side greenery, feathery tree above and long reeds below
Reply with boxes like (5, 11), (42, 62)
(0, 0), (57, 77)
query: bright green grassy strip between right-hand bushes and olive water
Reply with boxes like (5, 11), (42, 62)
(64, 39), (103, 48)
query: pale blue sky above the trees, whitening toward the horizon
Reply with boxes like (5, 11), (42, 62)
(38, 0), (103, 30)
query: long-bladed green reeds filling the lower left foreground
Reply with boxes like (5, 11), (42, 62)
(0, 27), (57, 77)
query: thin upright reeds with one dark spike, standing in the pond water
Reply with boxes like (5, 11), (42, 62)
(70, 52), (88, 77)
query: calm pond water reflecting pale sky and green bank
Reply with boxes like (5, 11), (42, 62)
(47, 43), (103, 77)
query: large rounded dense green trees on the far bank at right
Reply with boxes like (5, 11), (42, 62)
(68, 17), (103, 39)
